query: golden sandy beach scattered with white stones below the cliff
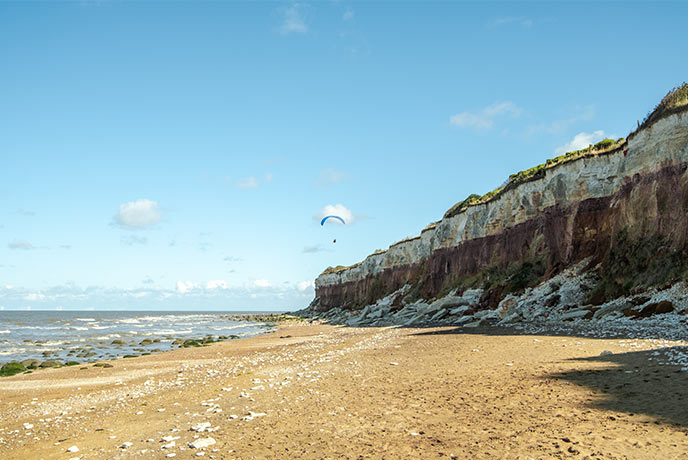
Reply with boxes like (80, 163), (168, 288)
(0, 323), (688, 460)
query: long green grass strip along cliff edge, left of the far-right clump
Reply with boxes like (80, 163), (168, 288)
(444, 137), (626, 218)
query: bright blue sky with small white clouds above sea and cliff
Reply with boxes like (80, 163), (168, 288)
(0, 0), (688, 310)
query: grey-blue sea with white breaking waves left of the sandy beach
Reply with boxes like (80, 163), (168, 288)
(0, 311), (282, 364)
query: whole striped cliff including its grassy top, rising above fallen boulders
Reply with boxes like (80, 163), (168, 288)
(310, 84), (688, 318)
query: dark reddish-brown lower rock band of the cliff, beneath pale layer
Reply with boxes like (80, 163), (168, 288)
(316, 162), (688, 311)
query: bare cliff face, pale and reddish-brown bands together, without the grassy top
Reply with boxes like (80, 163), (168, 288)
(314, 112), (688, 311)
